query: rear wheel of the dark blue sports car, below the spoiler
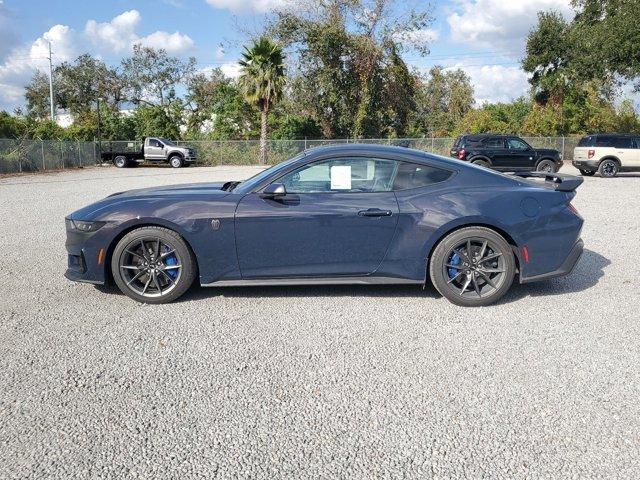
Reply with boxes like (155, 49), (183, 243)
(429, 227), (516, 307)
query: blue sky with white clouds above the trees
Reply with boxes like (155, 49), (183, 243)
(0, 0), (632, 111)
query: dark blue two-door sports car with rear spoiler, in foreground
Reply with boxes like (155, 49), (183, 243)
(66, 144), (583, 306)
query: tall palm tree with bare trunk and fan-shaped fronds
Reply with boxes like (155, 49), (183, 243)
(239, 37), (285, 164)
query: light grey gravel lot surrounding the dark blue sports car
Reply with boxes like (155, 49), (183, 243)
(0, 163), (640, 479)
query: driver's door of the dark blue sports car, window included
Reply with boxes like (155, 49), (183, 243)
(235, 157), (399, 279)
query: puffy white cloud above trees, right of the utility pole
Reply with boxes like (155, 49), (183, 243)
(84, 10), (141, 52)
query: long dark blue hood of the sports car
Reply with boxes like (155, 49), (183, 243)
(68, 182), (229, 220)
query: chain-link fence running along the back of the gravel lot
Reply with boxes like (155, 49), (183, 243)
(0, 137), (580, 174)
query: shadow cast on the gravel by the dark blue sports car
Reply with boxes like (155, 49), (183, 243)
(96, 249), (611, 305)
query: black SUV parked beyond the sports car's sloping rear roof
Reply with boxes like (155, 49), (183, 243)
(451, 133), (562, 172)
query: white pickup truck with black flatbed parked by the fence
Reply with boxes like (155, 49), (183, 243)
(100, 137), (196, 168)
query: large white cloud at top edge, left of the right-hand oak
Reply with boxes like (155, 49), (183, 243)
(447, 0), (573, 54)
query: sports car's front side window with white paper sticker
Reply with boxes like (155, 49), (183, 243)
(278, 157), (398, 193)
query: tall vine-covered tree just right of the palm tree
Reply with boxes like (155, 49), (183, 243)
(269, 0), (432, 138)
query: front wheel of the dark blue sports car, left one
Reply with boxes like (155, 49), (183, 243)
(111, 227), (197, 304)
